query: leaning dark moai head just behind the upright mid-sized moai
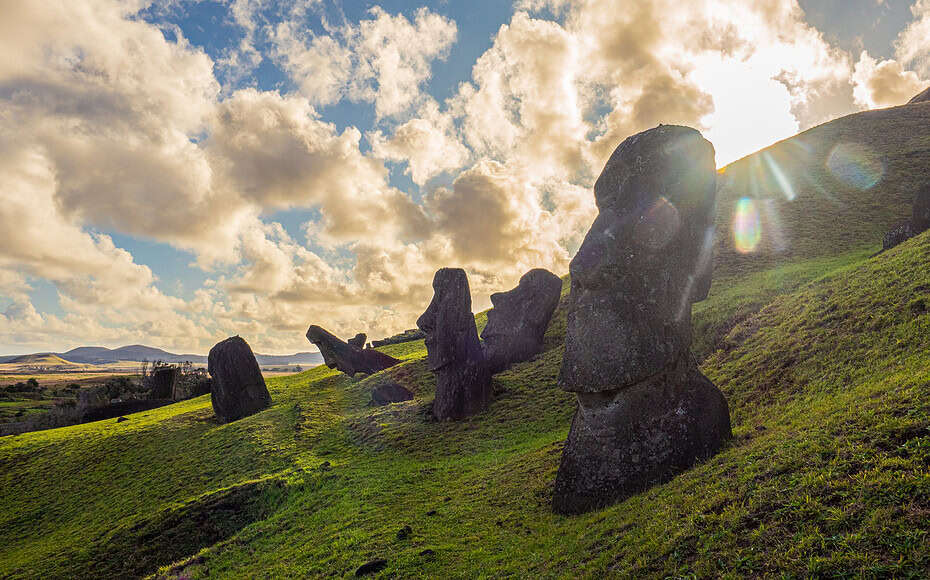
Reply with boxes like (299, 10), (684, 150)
(481, 268), (562, 373)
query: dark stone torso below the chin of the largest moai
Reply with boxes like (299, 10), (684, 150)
(552, 361), (730, 514)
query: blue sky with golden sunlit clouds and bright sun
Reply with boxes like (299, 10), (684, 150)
(0, 0), (930, 354)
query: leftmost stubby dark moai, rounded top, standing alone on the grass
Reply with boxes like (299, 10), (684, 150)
(207, 336), (271, 423)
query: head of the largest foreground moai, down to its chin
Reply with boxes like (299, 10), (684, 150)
(560, 125), (716, 392)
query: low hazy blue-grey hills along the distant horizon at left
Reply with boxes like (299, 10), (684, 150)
(0, 344), (323, 366)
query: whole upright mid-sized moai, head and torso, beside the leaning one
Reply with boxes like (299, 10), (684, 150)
(417, 268), (491, 421)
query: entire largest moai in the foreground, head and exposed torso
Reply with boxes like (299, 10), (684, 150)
(553, 125), (730, 513)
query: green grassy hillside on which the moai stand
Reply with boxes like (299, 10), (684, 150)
(0, 104), (930, 578)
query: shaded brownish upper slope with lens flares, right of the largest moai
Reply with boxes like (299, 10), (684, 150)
(714, 102), (930, 280)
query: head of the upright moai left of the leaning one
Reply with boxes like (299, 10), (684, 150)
(417, 268), (481, 371)
